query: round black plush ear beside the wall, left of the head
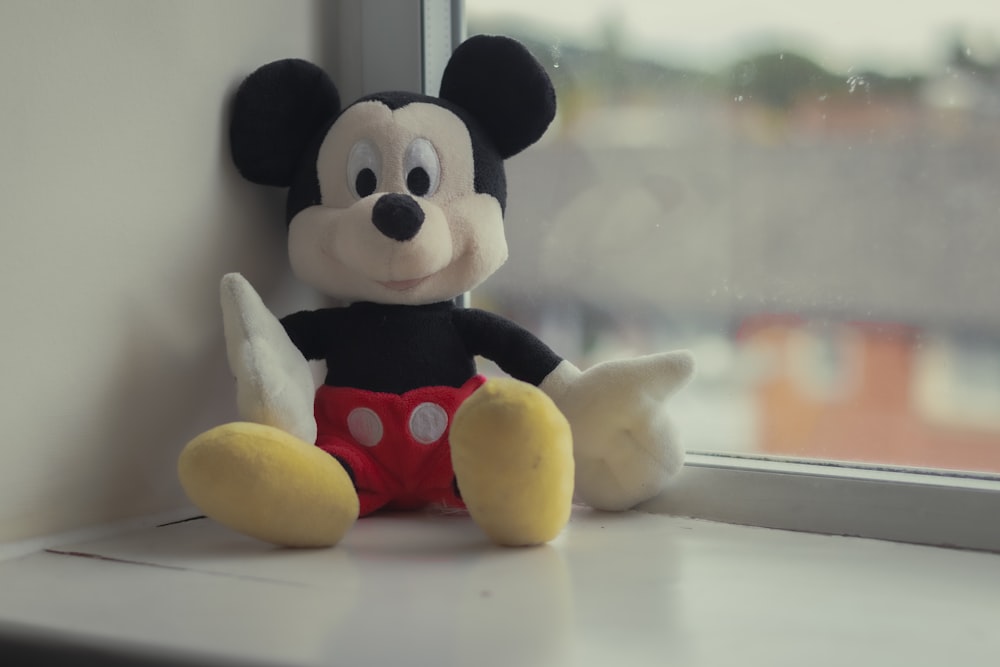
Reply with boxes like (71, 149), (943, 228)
(229, 59), (340, 187)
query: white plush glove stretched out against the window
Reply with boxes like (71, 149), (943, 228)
(539, 351), (694, 510)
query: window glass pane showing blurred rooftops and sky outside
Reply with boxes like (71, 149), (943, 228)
(467, 0), (1000, 472)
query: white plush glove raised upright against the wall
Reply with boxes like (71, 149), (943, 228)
(220, 273), (316, 443)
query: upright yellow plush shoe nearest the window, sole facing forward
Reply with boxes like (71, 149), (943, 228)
(451, 378), (573, 546)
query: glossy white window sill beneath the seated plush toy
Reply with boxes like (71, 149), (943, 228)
(0, 510), (1000, 667)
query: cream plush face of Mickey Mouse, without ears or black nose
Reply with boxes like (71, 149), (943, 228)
(288, 101), (507, 305)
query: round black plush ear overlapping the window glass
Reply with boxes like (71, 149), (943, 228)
(440, 35), (556, 160)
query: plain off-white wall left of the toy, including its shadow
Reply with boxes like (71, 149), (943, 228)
(0, 0), (331, 542)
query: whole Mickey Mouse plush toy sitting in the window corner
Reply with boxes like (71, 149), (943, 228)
(178, 36), (693, 547)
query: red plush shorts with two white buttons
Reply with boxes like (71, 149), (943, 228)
(315, 375), (486, 516)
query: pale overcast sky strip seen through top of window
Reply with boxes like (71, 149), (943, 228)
(466, 0), (1000, 73)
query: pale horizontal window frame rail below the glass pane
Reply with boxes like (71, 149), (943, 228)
(638, 452), (1000, 553)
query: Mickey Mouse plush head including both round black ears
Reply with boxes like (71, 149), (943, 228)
(230, 36), (555, 305)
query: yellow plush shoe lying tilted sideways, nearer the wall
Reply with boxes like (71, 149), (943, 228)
(178, 422), (358, 547)
